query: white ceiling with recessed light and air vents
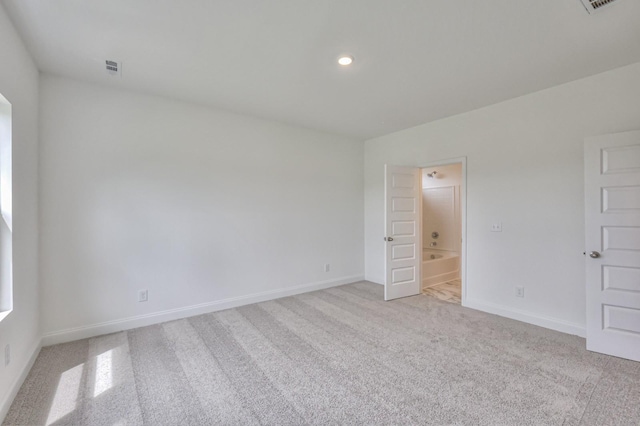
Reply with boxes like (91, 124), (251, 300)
(0, 0), (640, 139)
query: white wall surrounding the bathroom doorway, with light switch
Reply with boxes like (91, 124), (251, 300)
(365, 64), (640, 334)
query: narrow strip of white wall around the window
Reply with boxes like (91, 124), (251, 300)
(0, 5), (40, 422)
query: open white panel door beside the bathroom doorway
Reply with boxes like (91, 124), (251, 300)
(384, 165), (422, 300)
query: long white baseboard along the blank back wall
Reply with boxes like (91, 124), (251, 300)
(42, 275), (364, 346)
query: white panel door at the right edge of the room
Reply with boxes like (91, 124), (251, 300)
(584, 131), (640, 361)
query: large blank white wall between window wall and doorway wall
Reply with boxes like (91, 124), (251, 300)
(40, 75), (364, 343)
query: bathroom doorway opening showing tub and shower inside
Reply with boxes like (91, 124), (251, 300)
(420, 160), (466, 304)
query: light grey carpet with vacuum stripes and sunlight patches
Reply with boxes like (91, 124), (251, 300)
(5, 282), (640, 426)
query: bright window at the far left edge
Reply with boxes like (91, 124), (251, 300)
(0, 95), (13, 321)
